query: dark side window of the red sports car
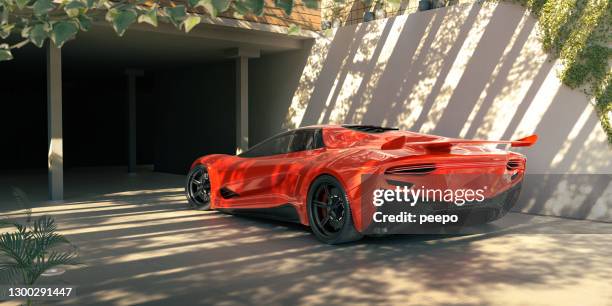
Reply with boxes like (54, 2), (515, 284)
(239, 129), (323, 157)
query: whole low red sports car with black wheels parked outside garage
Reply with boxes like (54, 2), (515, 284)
(185, 125), (537, 244)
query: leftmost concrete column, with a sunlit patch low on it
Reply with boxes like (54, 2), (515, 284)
(47, 42), (64, 200)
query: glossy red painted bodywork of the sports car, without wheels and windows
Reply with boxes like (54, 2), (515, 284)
(192, 125), (537, 231)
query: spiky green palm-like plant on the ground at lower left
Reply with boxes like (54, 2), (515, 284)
(0, 216), (79, 286)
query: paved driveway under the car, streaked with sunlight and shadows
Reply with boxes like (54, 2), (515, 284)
(0, 171), (612, 305)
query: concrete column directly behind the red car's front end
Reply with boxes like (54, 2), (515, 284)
(236, 56), (249, 154)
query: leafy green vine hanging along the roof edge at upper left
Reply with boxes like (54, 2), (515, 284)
(0, 0), (320, 61)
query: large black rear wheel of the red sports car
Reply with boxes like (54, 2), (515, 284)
(307, 175), (363, 244)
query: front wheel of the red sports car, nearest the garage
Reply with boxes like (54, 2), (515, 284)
(185, 165), (210, 210)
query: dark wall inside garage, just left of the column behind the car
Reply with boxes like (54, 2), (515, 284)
(154, 61), (236, 174)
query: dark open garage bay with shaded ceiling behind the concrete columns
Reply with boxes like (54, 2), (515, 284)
(0, 23), (301, 203)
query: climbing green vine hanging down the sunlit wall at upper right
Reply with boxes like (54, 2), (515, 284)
(515, 0), (612, 144)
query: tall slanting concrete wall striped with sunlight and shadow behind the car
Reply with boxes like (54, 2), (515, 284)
(251, 3), (612, 221)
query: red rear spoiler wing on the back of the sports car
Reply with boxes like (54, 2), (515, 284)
(380, 134), (538, 153)
